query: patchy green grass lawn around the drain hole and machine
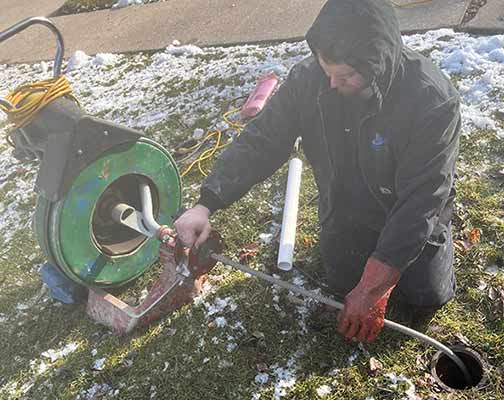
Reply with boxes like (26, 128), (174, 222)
(0, 127), (504, 399)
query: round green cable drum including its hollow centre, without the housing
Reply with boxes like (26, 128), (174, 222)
(34, 137), (181, 288)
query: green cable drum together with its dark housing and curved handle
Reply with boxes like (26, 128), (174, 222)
(0, 17), (181, 288)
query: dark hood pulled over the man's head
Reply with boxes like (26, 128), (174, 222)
(306, 0), (403, 104)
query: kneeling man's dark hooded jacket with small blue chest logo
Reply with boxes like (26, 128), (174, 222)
(199, 0), (460, 270)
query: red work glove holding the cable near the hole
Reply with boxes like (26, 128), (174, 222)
(338, 257), (401, 342)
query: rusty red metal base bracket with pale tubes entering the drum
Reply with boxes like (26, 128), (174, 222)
(86, 182), (223, 334)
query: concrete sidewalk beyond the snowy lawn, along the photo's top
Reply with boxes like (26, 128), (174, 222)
(0, 0), (504, 63)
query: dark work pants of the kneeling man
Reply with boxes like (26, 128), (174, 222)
(320, 220), (456, 308)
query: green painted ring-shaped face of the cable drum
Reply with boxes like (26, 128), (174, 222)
(42, 138), (181, 287)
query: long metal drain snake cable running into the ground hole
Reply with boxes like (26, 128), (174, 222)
(211, 253), (473, 385)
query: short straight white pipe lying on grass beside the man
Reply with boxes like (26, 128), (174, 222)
(277, 158), (303, 271)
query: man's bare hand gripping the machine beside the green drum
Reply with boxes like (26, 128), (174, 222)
(174, 204), (212, 248)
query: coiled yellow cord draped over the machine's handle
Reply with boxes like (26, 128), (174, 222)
(0, 76), (78, 141)
